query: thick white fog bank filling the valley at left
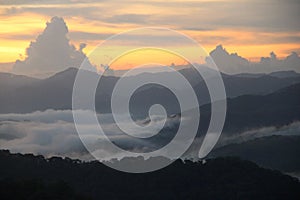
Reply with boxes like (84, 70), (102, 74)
(0, 110), (178, 160)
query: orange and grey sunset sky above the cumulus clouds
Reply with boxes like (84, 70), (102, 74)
(0, 0), (300, 71)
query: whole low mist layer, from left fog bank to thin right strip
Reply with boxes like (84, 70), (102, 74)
(0, 110), (300, 160)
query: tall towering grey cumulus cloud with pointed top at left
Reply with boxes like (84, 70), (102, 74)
(13, 17), (90, 77)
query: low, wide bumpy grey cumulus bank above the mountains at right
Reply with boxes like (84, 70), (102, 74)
(206, 45), (300, 74)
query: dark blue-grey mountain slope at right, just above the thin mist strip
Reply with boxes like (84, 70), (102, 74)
(200, 84), (300, 134)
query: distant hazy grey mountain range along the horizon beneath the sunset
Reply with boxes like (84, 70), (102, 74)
(0, 68), (300, 117)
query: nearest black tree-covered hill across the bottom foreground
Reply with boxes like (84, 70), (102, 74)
(0, 151), (300, 199)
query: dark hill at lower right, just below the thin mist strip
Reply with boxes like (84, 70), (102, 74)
(209, 135), (300, 172)
